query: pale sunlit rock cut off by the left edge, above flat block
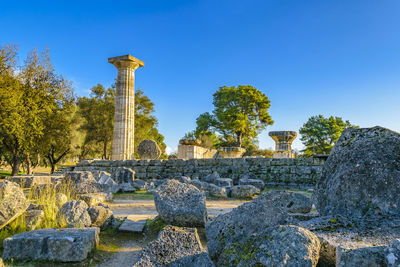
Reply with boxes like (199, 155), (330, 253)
(0, 181), (29, 229)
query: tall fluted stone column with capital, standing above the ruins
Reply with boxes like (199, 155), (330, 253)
(108, 55), (144, 160)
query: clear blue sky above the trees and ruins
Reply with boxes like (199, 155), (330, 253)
(0, 0), (400, 154)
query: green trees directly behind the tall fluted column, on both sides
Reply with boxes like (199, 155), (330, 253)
(78, 87), (166, 159)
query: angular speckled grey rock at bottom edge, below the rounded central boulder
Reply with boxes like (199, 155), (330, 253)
(133, 225), (202, 267)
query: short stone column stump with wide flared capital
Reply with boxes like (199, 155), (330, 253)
(268, 131), (297, 158)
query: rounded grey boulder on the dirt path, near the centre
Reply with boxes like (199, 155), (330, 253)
(154, 180), (207, 226)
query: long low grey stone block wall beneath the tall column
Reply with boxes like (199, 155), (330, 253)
(72, 158), (324, 188)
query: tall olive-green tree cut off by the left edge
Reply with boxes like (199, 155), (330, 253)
(0, 46), (73, 175)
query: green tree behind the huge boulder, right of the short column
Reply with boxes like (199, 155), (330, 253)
(300, 115), (358, 156)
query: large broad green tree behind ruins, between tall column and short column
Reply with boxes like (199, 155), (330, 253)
(195, 85), (273, 147)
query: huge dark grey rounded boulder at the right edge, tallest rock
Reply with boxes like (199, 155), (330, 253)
(314, 127), (400, 217)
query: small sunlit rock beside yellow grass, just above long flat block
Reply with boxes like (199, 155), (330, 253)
(57, 200), (92, 228)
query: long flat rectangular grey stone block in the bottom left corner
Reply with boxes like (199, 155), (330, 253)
(3, 227), (99, 262)
